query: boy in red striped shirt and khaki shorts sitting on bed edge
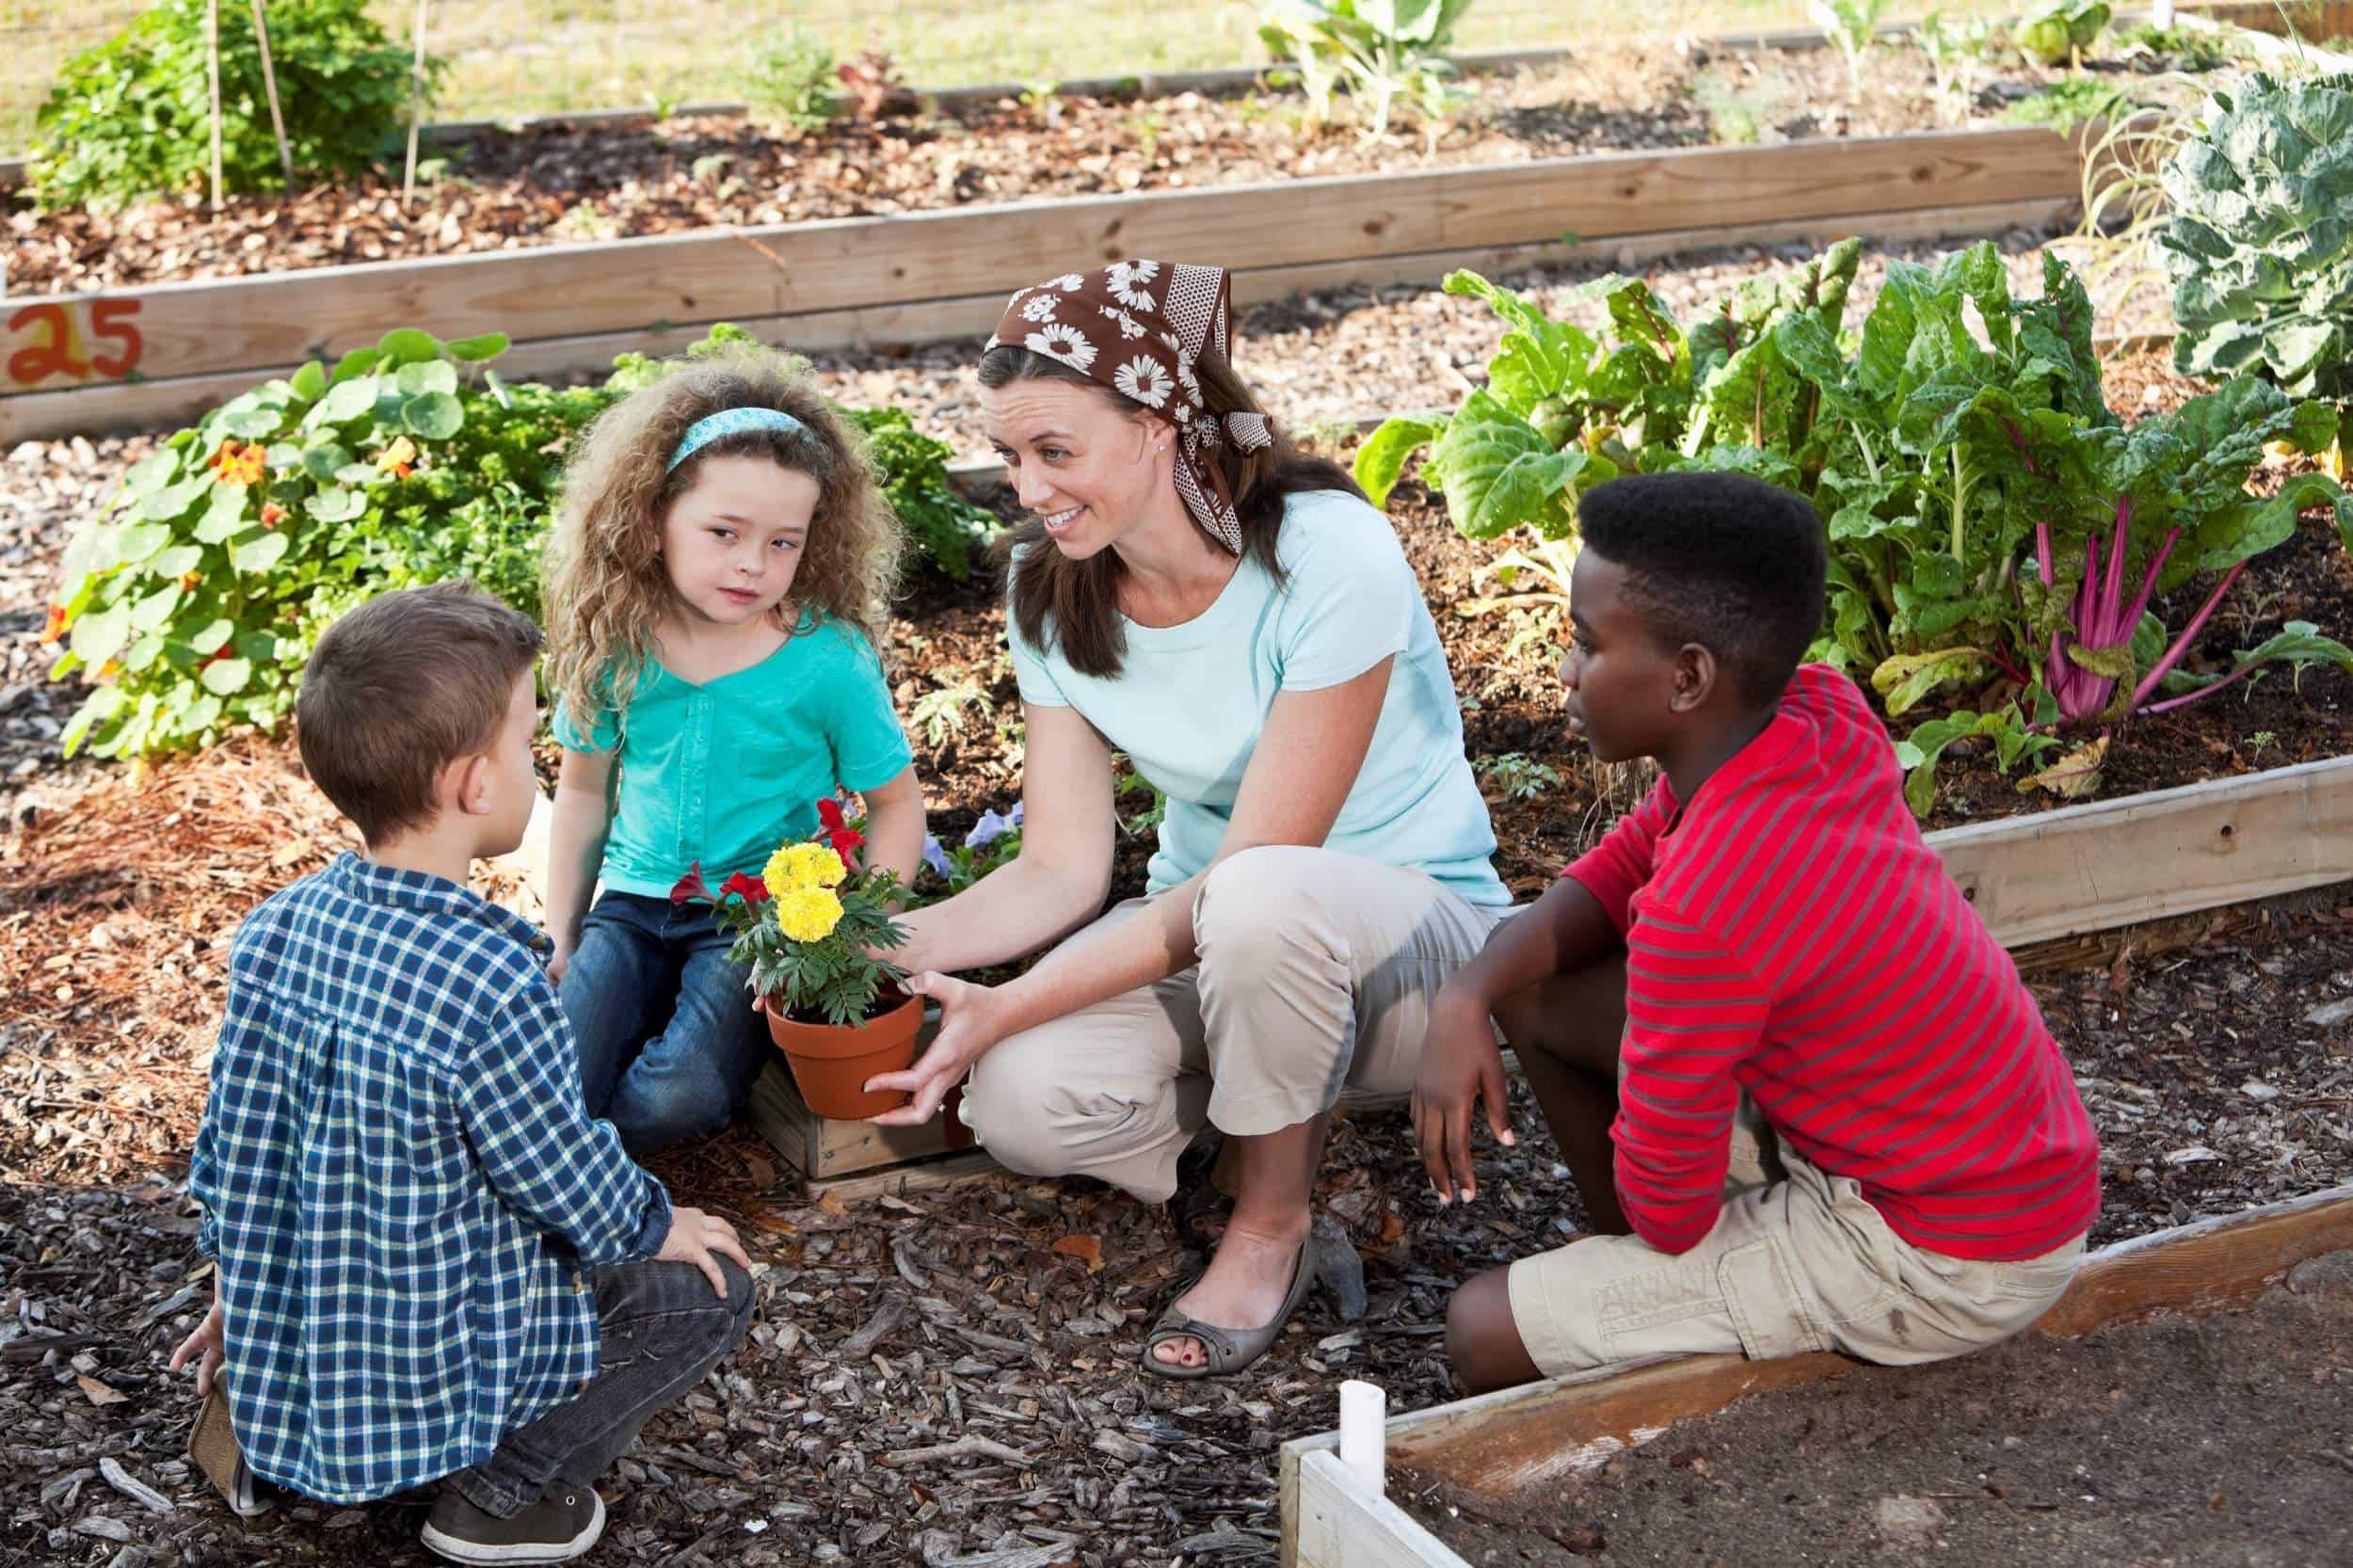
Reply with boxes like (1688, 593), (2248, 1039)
(1415, 473), (2099, 1389)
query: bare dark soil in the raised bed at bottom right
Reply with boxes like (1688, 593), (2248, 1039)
(1391, 1253), (2353, 1568)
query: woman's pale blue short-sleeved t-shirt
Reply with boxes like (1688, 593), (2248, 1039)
(1007, 489), (1511, 906)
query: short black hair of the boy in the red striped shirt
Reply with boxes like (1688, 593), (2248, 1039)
(1577, 473), (1829, 706)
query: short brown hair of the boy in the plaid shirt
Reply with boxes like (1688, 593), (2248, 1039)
(295, 582), (539, 848)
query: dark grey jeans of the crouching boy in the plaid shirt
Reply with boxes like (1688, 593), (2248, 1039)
(442, 1257), (758, 1518)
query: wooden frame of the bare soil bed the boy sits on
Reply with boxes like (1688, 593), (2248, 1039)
(1283, 1187), (2353, 1568)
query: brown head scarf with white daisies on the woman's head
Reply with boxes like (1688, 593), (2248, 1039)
(988, 262), (1275, 555)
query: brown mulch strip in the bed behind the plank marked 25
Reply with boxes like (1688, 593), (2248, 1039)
(8, 42), (2196, 295)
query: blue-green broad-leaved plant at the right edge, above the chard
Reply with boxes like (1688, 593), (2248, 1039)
(2158, 73), (2353, 482)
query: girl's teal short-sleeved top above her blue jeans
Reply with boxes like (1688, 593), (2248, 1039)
(555, 615), (913, 897)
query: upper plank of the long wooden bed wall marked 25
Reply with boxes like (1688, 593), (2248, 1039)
(0, 127), (2083, 409)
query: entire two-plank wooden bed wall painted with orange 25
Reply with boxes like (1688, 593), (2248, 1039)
(0, 118), (2083, 447)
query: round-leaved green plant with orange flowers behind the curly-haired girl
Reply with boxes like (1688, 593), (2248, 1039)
(42, 325), (996, 756)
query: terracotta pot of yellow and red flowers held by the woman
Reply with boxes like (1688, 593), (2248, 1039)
(671, 801), (922, 1121)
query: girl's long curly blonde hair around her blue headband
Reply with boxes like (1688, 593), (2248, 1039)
(546, 344), (904, 732)
